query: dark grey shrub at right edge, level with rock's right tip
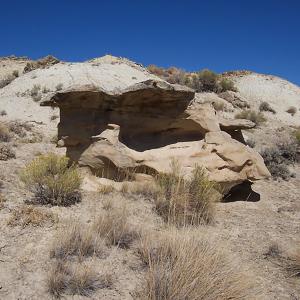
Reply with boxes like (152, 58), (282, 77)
(261, 142), (299, 180)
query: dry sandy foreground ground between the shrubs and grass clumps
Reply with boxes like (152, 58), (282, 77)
(0, 138), (300, 300)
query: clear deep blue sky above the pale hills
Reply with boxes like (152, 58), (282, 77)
(0, 0), (300, 85)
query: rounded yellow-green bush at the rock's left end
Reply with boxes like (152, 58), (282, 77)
(20, 153), (81, 206)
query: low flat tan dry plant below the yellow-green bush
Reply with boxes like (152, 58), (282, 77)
(7, 205), (58, 228)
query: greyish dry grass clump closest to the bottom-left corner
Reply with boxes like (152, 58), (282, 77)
(47, 261), (112, 298)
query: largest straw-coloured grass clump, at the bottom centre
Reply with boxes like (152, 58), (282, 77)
(137, 229), (255, 300)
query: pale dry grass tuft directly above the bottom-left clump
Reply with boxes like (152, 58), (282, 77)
(50, 221), (106, 260)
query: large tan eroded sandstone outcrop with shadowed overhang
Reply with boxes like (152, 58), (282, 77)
(42, 58), (269, 193)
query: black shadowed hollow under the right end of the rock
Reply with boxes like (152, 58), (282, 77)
(223, 181), (260, 202)
